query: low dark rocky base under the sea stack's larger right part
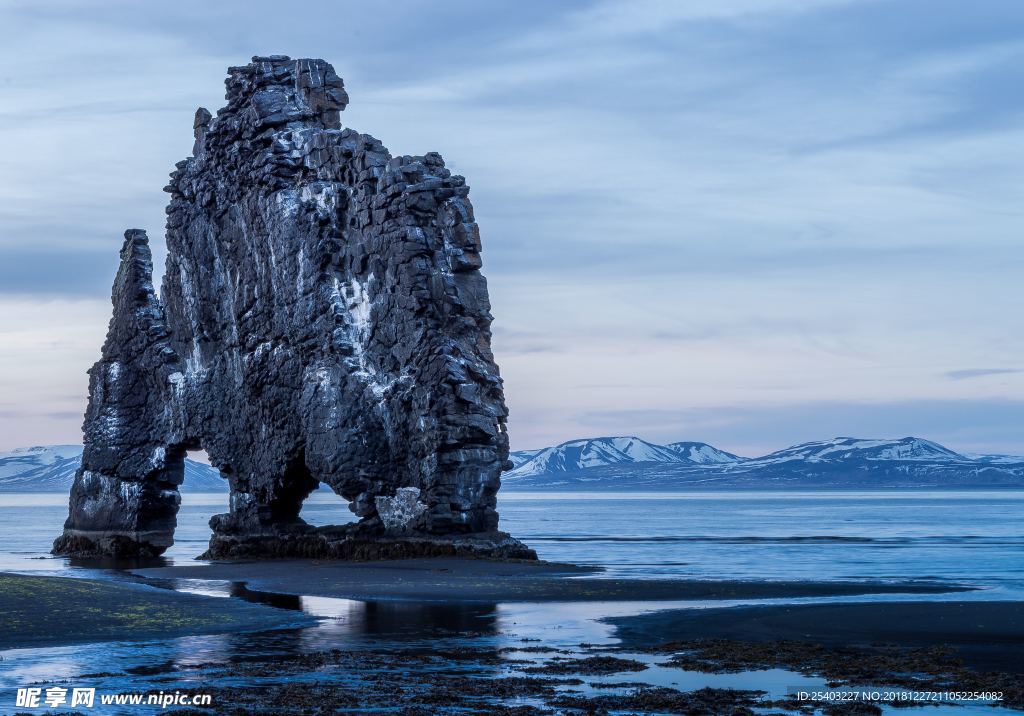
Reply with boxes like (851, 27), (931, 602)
(198, 527), (537, 561)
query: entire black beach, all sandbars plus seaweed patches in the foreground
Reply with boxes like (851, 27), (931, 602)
(0, 558), (1024, 716)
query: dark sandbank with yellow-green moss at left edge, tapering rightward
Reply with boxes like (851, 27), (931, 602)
(0, 573), (315, 649)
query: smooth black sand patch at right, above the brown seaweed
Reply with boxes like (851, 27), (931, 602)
(606, 601), (1024, 673)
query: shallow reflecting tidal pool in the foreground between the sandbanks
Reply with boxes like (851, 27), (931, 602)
(6, 580), (990, 714)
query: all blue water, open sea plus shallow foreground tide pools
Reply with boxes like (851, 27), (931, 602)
(0, 492), (1024, 714)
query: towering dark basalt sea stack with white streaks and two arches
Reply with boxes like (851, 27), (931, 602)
(53, 56), (536, 558)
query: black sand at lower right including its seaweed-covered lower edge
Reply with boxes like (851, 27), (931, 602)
(604, 601), (1024, 714)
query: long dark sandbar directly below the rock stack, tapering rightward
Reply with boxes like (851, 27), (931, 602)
(133, 558), (971, 602)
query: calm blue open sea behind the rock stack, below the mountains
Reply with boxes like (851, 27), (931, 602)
(0, 491), (1024, 599)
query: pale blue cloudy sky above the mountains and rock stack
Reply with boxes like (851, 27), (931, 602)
(0, 0), (1024, 456)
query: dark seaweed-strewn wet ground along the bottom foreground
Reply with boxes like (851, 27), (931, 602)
(22, 639), (1024, 716)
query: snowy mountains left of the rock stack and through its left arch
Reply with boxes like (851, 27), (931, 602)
(0, 445), (227, 493)
